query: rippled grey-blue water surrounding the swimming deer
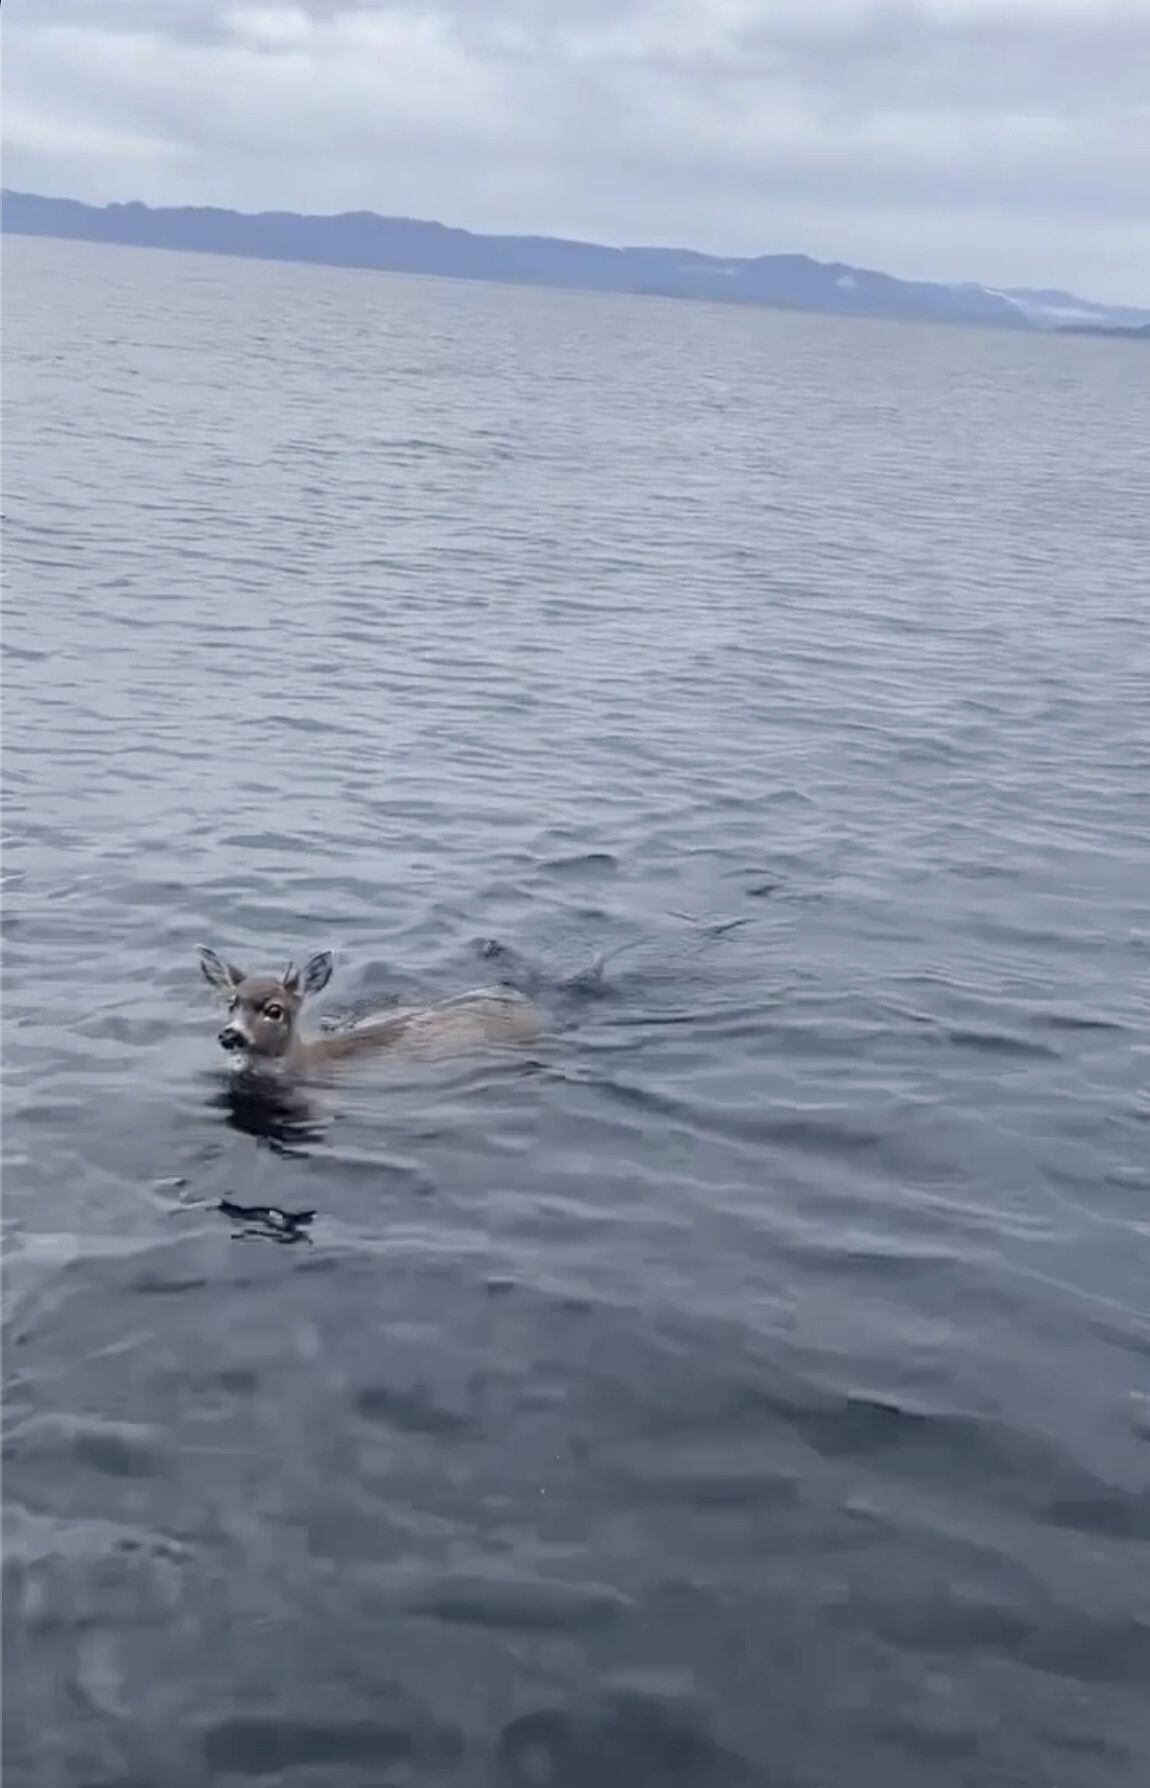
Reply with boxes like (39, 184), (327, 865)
(4, 240), (1150, 1788)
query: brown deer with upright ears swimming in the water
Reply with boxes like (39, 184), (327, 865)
(200, 946), (538, 1075)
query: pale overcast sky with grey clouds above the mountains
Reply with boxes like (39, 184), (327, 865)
(4, 0), (1150, 306)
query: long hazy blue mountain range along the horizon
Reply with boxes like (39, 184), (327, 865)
(2, 191), (1150, 329)
